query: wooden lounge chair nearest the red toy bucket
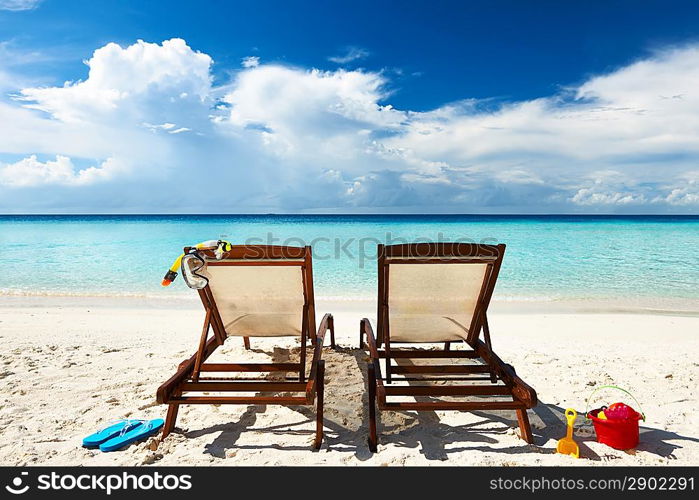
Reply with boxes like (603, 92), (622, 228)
(359, 243), (537, 451)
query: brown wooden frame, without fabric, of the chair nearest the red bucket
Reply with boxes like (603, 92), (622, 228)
(359, 243), (537, 452)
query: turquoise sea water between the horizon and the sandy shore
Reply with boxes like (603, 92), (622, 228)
(0, 215), (699, 300)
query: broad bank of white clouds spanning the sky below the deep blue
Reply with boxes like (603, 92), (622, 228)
(0, 39), (699, 212)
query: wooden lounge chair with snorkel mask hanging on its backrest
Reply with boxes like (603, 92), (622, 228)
(157, 245), (335, 449)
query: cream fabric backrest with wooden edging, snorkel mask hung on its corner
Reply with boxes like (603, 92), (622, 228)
(185, 245), (315, 339)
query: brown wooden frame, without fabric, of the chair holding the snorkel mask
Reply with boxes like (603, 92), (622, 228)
(156, 245), (335, 449)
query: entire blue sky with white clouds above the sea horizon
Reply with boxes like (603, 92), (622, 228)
(0, 0), (699, 214)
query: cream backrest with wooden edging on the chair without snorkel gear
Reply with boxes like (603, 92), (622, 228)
(377, 243), (505, 344)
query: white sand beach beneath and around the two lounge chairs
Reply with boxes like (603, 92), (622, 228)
(0, 297), (699, 465)
